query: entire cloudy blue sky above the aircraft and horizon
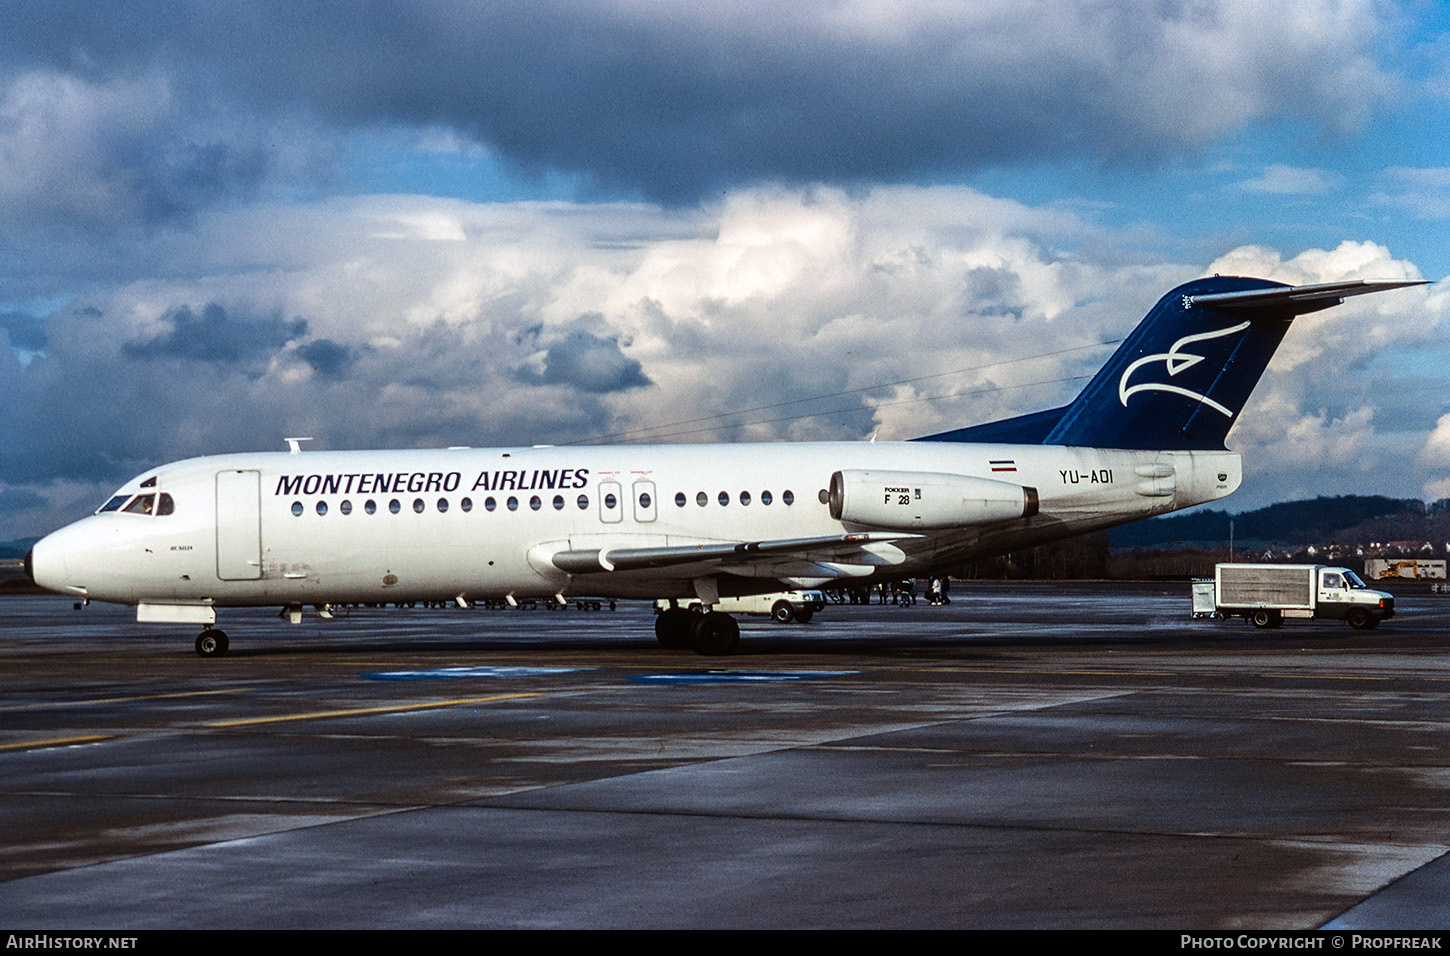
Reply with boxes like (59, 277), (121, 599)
(0, 0), (1450, 541)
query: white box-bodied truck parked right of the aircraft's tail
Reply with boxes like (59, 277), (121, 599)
(1214, 564), (1395, 628)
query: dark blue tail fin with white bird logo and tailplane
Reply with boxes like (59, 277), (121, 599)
(927, 276), (1422, 450)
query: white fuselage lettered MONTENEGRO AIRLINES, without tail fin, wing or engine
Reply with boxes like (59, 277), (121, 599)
(32, 441), (1240, 606)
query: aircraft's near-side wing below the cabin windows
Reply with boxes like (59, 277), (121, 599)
(550, 531), (922, 577)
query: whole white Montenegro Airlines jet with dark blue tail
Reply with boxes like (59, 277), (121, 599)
(25, 276), (1422, 656)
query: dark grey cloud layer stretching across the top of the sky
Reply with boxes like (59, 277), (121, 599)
(0, 0), (1396, 201)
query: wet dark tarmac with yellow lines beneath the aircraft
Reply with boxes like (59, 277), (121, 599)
(0, 583), (1450, 930)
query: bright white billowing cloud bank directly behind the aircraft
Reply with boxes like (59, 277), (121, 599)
(0, 187), (1450, 540)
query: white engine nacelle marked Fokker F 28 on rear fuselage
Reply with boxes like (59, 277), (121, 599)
(828, 471), (1037, 531)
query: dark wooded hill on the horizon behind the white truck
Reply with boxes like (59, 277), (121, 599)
(1108, 495), (1432, 548)
